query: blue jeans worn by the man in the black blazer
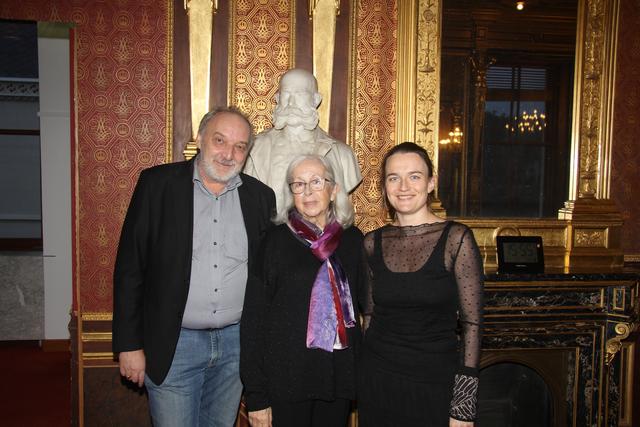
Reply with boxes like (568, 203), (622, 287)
(144, 325), (242, 427)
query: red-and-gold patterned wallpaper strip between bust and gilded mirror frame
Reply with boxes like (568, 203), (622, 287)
(350, 0), (398, 232)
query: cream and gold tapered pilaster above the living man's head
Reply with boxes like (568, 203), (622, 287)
(183, 0), (218, 159)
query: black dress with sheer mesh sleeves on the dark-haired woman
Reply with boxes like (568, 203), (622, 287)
(358, 221), (482, 427)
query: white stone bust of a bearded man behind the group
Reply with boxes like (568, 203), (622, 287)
(244, 68), (362, 208)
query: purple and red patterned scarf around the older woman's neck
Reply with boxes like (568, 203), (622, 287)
(289, 209), (356, 352)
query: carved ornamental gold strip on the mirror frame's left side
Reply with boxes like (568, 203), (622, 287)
(415, 0), (442, 164)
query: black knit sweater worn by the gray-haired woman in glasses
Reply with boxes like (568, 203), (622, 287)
(240, 224), (364, 411)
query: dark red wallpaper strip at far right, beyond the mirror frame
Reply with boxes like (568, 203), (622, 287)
(611, 0), (640, 255)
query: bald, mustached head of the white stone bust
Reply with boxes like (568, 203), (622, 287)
(273, 68), (322, 130)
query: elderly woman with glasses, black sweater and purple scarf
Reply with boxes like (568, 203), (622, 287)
(240, 155), (363, 427)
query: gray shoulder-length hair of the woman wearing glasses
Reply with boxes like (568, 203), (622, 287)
(273, 154), (355, 228)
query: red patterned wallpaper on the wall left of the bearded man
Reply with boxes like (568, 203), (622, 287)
(0, 0), (170, 312)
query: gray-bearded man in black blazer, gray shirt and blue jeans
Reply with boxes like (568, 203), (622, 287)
(113, 108), (275, 427)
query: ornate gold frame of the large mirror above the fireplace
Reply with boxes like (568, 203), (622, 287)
(397, 0), (623, 270)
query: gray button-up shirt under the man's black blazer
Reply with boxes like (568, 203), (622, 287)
(182, 159), (249, 329)
